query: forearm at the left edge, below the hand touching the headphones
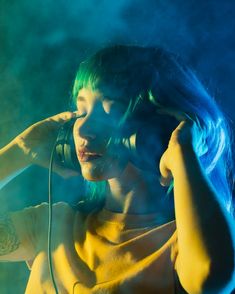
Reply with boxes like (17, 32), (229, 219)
(0, 140), (30, 186)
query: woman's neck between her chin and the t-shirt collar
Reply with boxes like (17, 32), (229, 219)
(105, 163), (170, 214)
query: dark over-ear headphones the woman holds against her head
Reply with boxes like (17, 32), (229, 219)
(55, 115), (179, 173)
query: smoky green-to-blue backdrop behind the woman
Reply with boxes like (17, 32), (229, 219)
(0, 0), (235, 294)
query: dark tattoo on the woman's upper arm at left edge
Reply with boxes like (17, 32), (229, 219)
(0, 214), (20, 256)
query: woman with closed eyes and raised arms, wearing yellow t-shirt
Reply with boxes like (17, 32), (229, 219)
(0, 46), (234, 294)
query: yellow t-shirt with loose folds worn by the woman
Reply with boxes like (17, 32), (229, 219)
(12, 202), (182, 294)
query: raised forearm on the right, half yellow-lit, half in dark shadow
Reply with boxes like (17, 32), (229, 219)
(171, 147), (234, 292)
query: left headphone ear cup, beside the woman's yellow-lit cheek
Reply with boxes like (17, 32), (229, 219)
(56, 119), (81, 173)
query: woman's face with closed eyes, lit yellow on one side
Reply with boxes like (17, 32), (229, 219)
(73, 88), (128, 181)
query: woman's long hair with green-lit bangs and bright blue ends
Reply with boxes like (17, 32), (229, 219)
(73, 45), (234, 213)
